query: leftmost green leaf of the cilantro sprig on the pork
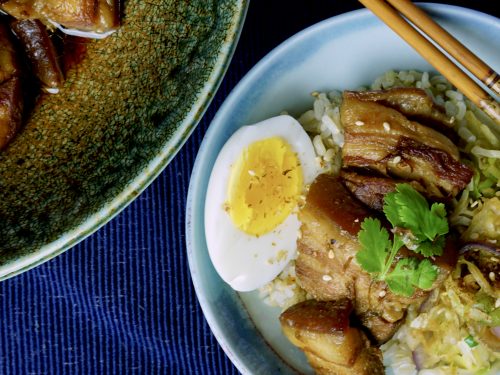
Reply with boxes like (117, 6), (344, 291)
(356, 218), (391, 273)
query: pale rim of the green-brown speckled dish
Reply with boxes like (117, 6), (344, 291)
(0, 0), (250, 281)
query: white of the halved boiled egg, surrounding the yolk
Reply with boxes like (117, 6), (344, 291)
(205, 116), (320, 291)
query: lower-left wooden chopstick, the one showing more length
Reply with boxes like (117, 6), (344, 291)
(359, 0), (500, 125)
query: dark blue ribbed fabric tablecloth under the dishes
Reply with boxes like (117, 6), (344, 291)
(0, 0), (499, 374)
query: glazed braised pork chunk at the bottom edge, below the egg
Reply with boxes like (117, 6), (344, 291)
(280, 300), (384, 375)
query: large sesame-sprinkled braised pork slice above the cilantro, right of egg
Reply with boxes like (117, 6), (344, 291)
(340, 92), (473, 199)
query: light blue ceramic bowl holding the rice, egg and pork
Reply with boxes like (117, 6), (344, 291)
(186, 4), (500, 374)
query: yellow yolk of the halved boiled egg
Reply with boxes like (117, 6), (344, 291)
(226, 137), (303, 236)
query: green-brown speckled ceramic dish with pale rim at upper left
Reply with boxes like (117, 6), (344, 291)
(0, 0), (248, 279)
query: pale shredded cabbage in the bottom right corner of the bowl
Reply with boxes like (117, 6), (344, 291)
(381, 259), (500, 375)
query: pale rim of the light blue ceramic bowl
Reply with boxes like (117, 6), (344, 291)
(185, 3), (498, 374)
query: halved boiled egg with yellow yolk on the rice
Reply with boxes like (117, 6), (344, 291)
(205, 116), (320, 291)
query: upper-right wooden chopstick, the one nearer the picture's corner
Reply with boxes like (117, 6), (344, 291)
(386, 0), (500, 95)
